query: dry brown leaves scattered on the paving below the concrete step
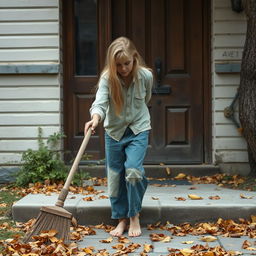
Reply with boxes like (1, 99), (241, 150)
(0, 216), (256, 256)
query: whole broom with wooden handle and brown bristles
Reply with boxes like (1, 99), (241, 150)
(23, 129), (91, 243)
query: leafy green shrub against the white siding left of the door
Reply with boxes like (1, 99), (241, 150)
(15, 127), (67, 186)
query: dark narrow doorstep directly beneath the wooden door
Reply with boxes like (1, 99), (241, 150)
(79, 164), (220, 178)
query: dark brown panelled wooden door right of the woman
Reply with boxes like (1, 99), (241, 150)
(146, 0), (203, 163)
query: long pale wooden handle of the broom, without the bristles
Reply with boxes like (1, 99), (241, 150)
(55, 128), (92, 207)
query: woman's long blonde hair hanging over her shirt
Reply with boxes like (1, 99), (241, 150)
(101, 37), (146, 115)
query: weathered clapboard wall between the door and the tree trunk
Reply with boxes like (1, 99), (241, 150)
(211, 0), (249, 174)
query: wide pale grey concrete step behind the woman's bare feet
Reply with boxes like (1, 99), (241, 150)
(12, 184), (256, 226)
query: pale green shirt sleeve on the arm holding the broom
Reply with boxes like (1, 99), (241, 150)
(90, 78), (109, 122)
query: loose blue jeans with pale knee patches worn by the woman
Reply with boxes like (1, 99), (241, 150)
(105, 128), (149, 219)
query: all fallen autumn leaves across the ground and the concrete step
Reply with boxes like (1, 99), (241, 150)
(0, 174), (256, 256)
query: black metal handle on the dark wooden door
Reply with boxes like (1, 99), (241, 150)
(152, 58), (172, 94)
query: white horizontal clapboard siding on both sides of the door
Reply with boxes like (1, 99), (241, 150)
(0, 0), (249, 183)
